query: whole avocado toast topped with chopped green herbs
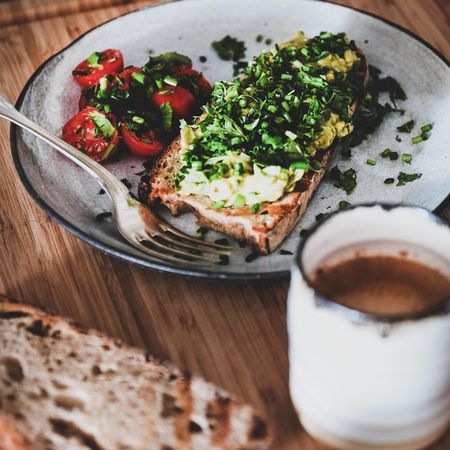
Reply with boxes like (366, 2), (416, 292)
(140, 32), (368, 254)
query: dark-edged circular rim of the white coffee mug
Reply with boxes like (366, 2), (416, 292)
(293, 202), (450, 323)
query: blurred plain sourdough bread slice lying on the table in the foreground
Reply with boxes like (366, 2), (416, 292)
(0, 298), (270, 450)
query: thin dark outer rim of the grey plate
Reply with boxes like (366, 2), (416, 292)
(10, 0), (450, 281)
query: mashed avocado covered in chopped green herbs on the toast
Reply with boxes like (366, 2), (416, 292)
(175, 32), (363, 212)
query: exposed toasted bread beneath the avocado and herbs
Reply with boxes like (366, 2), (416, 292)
(139, 50), (368, 255)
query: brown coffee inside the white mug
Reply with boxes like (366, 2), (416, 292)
(311, 256), (450, 315)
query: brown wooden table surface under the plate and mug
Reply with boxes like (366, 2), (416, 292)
(0, 0), (450, 450)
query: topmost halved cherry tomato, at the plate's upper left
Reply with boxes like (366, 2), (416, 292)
(72, 48), (123, 87)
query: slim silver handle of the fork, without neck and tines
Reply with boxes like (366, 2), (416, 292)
(0, 92), (131, 202)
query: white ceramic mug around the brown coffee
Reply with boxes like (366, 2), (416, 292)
(288, 205), (450, 450)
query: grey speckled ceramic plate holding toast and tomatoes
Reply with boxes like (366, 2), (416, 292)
(11, 0), (450, 279)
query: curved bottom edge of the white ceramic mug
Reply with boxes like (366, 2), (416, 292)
(298, 411), (448, 450)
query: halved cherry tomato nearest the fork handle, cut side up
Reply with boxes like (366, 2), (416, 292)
(62, 107), (119, 162)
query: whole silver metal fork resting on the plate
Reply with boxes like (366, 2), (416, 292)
(0, 92), (230, 265)
